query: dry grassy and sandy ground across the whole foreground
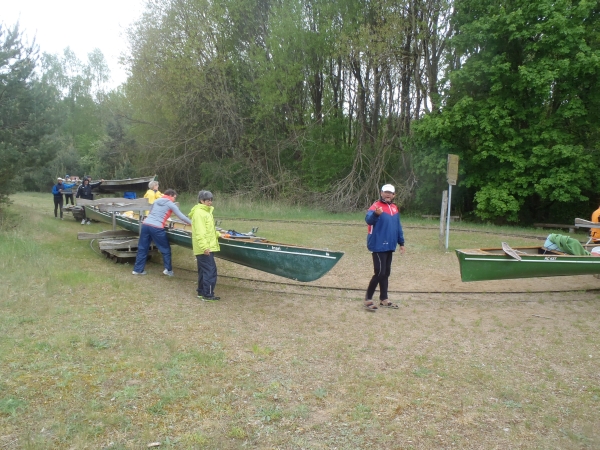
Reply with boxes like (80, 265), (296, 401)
(0, 194), (600, 449)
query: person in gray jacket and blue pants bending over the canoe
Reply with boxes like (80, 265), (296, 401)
(132, 189), (192, 277)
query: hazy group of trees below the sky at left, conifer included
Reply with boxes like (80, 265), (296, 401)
(0, 26), (122, 196)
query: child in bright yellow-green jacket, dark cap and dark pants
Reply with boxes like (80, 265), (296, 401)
(188, 191), (221, 302)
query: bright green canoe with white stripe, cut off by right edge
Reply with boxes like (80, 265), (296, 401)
(456, 247), (600, 282)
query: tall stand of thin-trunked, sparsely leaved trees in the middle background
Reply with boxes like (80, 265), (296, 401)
(125, 0), (450, 209)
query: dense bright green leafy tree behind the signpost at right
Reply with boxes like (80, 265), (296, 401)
(417, 0), (600, 221)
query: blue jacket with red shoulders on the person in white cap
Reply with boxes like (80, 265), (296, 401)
(365, 199), (404, 252)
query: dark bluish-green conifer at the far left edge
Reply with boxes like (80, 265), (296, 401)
(0, 23), (58, 209)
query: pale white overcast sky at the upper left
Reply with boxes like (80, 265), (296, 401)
(0, 0), (144, 87)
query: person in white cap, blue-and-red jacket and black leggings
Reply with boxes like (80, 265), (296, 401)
(364, 184), (405, 311)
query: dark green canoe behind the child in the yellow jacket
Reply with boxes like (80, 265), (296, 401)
(85, 206), (344, 282)
